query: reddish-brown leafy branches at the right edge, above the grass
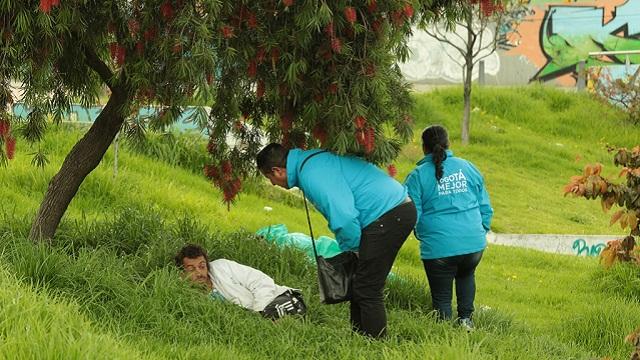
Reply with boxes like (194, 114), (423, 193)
(564, 146), (640, 267)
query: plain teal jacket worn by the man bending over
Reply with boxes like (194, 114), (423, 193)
(287, 149), (407, 251)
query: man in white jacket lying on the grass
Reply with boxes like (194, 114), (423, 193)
(175, 244), (307, 320)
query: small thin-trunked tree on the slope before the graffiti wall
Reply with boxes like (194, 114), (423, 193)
(425, 0), (530, 145)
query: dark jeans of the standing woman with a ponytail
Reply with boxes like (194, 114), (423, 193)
(422, 251), (482, 320)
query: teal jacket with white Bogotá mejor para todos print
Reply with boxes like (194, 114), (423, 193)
(405, 150), (493, 259)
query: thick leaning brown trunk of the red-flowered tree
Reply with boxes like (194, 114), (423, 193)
(29, 86), (130, 241)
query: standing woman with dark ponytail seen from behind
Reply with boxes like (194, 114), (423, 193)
(405, 125), (493, 330)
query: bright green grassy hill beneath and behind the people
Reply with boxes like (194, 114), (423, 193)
(0, 87), (640, 359)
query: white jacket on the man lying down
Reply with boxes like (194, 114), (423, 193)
(209, 259), (295, 311)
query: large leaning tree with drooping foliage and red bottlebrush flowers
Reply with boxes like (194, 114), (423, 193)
(0, 0), (464, 240)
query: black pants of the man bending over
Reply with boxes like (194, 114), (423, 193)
(351, 202), (416, 338)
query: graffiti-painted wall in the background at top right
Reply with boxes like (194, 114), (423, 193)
(401, 0), (640, 87)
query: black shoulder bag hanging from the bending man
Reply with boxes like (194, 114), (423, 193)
(299, 150), (358, 304)
